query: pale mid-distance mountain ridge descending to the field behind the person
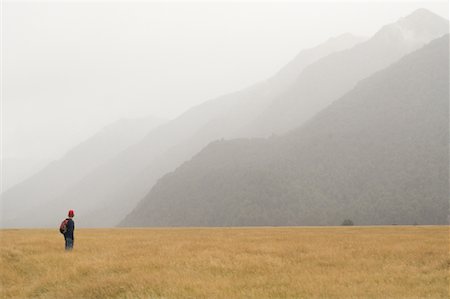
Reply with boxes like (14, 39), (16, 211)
(0, 34), (362, 226)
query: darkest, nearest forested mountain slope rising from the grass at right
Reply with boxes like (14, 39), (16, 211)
(122, 35), (450, 226)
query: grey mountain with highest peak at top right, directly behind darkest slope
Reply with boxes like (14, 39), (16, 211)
(241, 9), (449, 137)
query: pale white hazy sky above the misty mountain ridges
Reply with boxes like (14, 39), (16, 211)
(2, 1), (448, 159)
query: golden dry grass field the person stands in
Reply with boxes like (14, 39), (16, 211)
(0, 226), (450, 298)
